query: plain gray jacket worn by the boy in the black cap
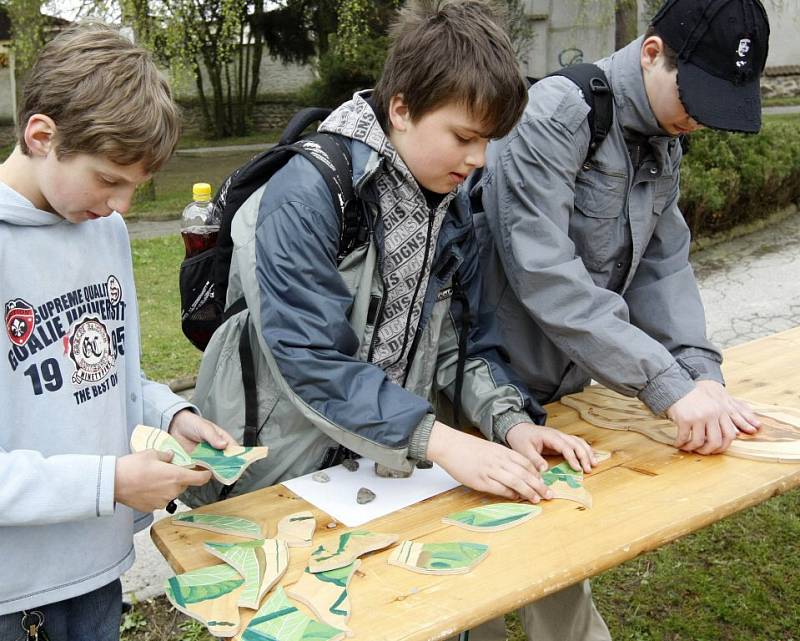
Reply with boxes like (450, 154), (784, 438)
(476, 38), (722, 414)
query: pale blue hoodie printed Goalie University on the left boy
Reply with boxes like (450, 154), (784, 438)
(0, 183), (189, 615)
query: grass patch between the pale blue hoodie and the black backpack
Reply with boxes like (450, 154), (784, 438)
(131, 234), (201, 381)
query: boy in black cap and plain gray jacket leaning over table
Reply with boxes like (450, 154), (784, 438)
(476, 0), (769, 641)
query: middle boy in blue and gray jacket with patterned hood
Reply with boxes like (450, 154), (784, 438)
(187, 0), (593, 503)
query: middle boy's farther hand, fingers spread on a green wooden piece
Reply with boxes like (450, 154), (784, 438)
(506, 423), (597, 472)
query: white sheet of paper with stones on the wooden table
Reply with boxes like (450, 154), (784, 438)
(283, 458), (461, 527)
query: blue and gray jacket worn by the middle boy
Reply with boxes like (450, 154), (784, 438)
(186, 96), (544, 505)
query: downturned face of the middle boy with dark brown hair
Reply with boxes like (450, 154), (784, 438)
(389, 96), (489, 194)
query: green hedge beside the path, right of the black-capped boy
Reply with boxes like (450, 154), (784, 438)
(680, 119), (800, 236)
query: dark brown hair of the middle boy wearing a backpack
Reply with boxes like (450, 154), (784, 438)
(374, 0), (527, 138)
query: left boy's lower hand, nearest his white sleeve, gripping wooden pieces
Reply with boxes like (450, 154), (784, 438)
(114, 450), (211, 512)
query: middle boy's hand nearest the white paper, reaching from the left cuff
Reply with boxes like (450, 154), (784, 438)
(427, 421), (552, 503)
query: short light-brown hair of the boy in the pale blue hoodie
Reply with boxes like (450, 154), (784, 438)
(17, 22), (180, 173)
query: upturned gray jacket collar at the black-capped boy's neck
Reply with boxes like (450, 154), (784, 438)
(597, 36), (669, 137)
